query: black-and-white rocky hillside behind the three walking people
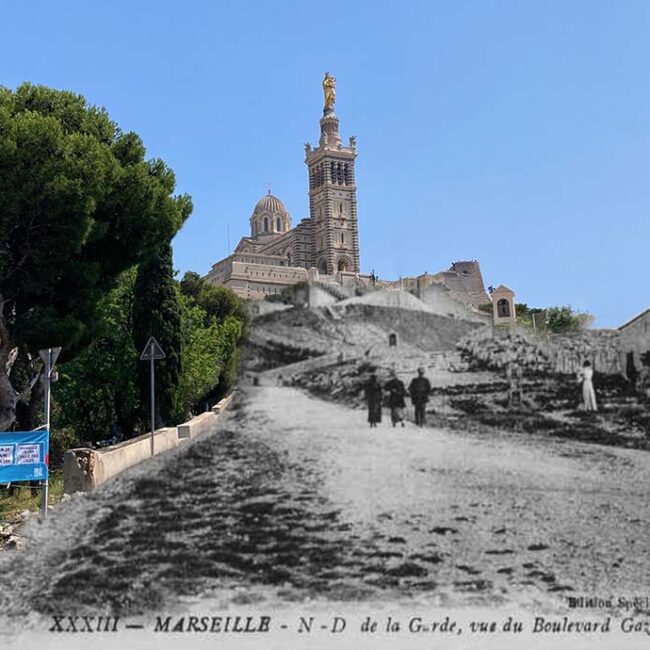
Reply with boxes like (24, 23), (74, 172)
(246, 292), (650, 449)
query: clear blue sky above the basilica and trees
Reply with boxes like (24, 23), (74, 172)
(0, 0), (650, 327)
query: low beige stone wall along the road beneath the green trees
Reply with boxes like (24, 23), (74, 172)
(63, 393), (233, 494)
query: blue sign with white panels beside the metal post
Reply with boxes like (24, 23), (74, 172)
(0, 431), (50, 484)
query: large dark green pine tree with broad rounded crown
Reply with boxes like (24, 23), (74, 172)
(0, 84), (192, 430)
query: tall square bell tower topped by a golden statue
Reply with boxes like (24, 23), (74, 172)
(305, 72), (359, 275)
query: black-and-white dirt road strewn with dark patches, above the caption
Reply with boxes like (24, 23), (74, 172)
(0, 386), (650, 615)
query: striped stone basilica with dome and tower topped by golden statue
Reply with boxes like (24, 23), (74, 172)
(205, 73), (362, 300)
